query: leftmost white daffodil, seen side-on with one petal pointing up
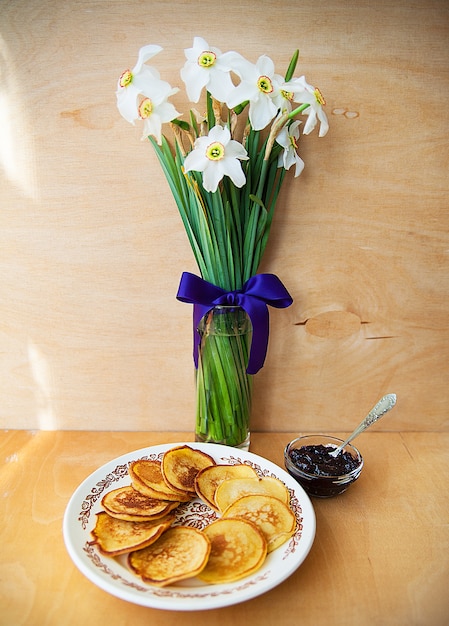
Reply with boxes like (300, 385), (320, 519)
(115, 44), (162, 124)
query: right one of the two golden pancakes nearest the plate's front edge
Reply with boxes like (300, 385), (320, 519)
(198, 519), (267, 584)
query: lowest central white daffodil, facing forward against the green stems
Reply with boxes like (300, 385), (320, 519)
(184, 126), (248, 192)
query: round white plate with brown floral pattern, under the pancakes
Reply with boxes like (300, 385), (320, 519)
(63, 443), (315, 611)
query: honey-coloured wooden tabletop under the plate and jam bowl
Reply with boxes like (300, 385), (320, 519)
(0, 431), (449, 626)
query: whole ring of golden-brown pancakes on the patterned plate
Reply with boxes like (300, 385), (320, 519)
(92, 445), (296, 587)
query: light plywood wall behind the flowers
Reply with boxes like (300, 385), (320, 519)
(0, 0), (449, 432)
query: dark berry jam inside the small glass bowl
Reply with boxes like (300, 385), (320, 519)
(290, 444), (359, 476)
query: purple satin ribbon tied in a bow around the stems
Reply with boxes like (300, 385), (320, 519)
(176, 272), (293, 374)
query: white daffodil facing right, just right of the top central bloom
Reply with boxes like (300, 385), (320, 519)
(226, 53), (280, 130)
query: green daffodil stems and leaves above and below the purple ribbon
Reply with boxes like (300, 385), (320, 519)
(150, 100), (298, 446)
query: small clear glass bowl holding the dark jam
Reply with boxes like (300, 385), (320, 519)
(284, 435), (363, 498)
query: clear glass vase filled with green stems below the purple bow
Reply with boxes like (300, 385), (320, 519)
(195, 306), (253, 450)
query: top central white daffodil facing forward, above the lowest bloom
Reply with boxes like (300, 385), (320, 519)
(181, 37), (236, 102)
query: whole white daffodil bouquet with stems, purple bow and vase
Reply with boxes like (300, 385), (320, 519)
(117, 37), (328, 445)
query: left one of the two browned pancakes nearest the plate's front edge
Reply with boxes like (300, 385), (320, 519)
(128, 526), (211, 587)
